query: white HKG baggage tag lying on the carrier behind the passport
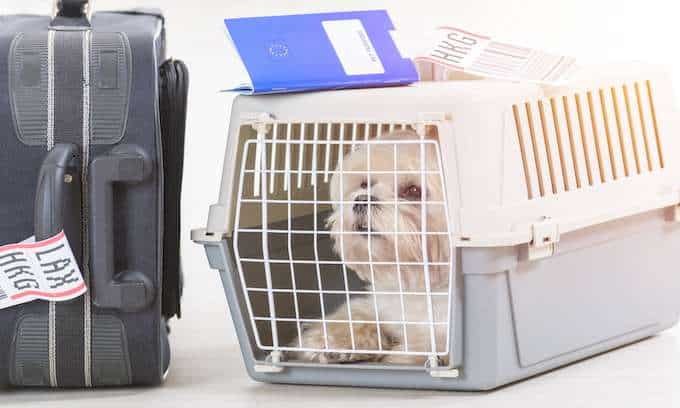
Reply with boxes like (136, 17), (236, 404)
(416, 27), (575, 84)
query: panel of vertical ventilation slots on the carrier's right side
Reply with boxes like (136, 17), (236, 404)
(512, 81), (664, 199)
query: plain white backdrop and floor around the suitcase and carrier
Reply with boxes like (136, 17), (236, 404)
(0, 0), (680, 408)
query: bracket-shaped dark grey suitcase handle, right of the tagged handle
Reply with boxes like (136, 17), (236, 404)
(89, 145), (155, 311)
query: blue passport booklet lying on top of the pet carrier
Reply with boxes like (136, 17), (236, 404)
(225, 10), (418, 94)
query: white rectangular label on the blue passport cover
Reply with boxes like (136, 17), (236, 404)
(322, 19), (385, 75)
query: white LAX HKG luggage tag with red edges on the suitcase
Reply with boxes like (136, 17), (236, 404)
(0, 231), (87, 310)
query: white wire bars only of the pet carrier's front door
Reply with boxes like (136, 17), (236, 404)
(233, 120), (455, 358)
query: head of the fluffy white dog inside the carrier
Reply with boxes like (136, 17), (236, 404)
(328, 131), (450, 291)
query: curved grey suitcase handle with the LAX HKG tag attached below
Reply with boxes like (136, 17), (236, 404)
(34, 144), (80, 242)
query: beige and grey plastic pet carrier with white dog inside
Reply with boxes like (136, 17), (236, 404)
(193, 64), (680, 390)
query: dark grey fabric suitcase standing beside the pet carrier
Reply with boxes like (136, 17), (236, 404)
(0, 0), (187, 388)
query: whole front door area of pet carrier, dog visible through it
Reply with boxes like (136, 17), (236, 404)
(233, 121), (455, 365)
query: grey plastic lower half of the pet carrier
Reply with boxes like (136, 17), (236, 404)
(197, 210), (680, 391)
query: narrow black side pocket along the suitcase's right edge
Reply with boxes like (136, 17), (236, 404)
(159, 59), (189, 319)
